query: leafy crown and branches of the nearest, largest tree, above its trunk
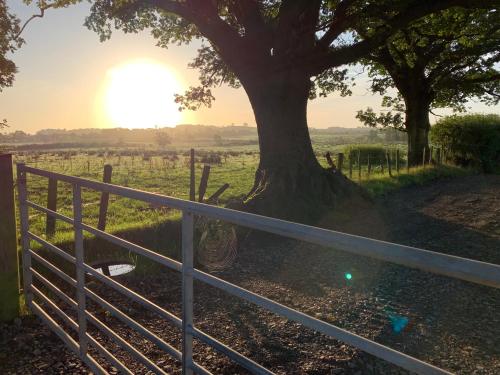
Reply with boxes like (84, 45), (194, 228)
(36, 0), (495, 109)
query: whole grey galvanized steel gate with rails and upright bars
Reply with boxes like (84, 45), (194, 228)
(17, 164), (500, 374)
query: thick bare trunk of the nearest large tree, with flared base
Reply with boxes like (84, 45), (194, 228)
(238, 72), (360, 222)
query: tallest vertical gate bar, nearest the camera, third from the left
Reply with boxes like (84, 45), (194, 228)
(182, 211), (194, 375)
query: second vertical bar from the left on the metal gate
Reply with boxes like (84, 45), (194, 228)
(73, 185), (88, 360)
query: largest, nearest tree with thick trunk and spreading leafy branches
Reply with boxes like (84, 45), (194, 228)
(28, 0), (499, 219)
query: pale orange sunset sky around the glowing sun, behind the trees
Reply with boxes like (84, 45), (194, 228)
(0, 0), (500, 133)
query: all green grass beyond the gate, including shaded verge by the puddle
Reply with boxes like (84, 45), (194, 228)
(0, 142), (470, 320)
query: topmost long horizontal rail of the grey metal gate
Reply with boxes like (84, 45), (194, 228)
(23, 166), (500, 288)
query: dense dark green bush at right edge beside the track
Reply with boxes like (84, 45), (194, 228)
(430, 114), (500, 173)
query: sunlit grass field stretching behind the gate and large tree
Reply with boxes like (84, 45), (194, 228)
(11, 142), (464, 242)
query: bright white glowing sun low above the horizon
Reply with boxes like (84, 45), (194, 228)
(103, 60), (182, 128)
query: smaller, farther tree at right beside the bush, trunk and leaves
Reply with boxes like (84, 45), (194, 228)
(357, 7), (500, 164)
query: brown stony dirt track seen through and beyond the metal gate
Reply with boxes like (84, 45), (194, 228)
(0, 175), (500, 375)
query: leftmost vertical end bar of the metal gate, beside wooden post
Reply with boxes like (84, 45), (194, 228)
(17, 164), (33, 308)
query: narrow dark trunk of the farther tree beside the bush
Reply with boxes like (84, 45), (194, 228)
(405, 95), (431, 166)
